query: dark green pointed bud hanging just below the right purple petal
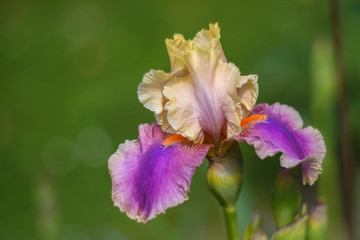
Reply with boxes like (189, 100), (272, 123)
(271, 168), (301, 228)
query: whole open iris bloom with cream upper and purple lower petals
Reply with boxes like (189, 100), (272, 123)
(109, 24), (325, 222)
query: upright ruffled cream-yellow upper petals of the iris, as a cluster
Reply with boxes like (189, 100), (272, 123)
(138, 23), (258, 148)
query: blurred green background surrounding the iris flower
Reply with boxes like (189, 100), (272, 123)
(0, 0), (360, 240)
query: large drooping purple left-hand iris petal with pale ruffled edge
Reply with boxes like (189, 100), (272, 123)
(109, 124), (210, 222)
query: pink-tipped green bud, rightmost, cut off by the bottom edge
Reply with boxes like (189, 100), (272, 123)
(306, 198), (327, 240)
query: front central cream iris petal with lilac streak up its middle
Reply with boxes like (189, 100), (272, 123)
(164, 47), (246, 145)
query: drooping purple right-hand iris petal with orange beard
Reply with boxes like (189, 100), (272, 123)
(235, 103), (326, 185)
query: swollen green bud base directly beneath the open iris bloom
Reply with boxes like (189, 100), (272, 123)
(206, 143), (242, 207)
